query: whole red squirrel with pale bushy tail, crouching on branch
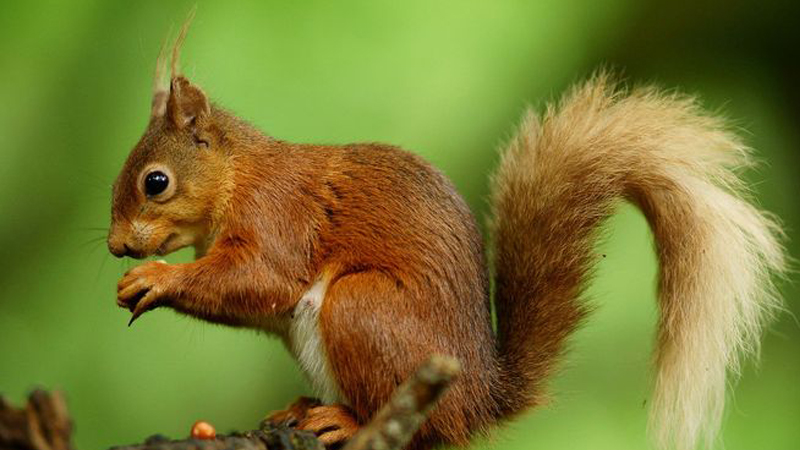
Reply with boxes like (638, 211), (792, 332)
(108, 16), (784, 450)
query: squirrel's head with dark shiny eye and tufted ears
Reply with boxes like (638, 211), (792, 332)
(108, 15), (227, 258)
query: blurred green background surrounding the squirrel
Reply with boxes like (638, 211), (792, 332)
(0, 0), (800, 450)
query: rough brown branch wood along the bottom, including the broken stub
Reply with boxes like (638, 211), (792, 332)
(0, 356), (460, 450)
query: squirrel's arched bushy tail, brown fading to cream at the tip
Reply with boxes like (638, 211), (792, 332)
(493, 74), (784, 449)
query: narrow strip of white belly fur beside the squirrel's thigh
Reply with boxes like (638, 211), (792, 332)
(289, 280), (344, 404)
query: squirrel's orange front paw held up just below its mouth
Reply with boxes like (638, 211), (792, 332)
(117, 261), (175, 326)
